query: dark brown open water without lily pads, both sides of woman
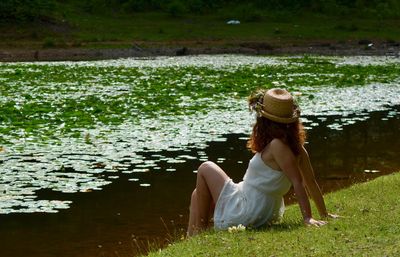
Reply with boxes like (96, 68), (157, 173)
(0, 107), (400, 257)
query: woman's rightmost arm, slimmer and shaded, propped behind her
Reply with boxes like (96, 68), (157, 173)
(299, 147), (329, 218)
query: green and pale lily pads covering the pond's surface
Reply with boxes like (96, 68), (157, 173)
(0, 55), (400, 213)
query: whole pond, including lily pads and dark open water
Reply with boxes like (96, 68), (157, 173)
(0, 55), (400, 254)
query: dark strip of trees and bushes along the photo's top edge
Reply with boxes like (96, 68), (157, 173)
(0, 0), (400, 22)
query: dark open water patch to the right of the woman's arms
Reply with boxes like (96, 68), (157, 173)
(308, 107), (400, 186)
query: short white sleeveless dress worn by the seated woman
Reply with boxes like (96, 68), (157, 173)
(214, 153), (292, 229)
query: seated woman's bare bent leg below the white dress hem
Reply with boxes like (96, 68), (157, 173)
(188, 162), (229, 236)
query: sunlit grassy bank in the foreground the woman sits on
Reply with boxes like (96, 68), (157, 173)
(150, 170), (400, 256)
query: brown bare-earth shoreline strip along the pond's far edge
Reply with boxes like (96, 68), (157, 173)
(0, 40), (400, 62)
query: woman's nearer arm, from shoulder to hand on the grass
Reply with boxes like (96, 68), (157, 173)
(270, 139), (326, 226)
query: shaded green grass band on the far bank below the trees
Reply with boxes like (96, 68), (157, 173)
(0, 3), (400, 48)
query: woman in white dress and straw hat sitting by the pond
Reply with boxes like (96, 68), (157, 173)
(187, 89), (337, 236)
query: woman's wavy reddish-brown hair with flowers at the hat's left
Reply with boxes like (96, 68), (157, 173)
(247, 90), (306, 155)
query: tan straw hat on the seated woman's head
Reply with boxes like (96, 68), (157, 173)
(260, 88), (299, 123)
